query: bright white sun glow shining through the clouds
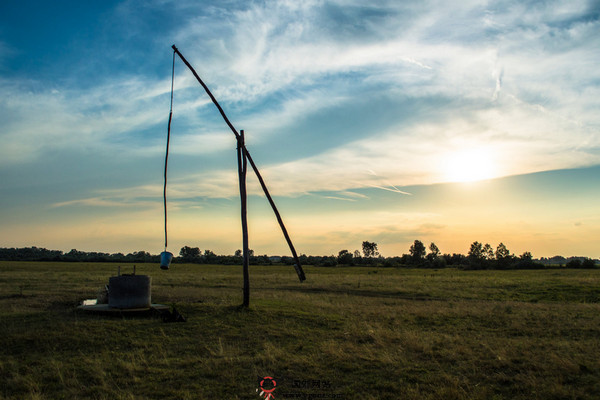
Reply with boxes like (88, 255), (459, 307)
(444, 148), (495, 182)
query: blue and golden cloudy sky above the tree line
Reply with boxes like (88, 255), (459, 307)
(0, 0), (600, 258)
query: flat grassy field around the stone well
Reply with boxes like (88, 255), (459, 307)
(0, 262), (600, 400)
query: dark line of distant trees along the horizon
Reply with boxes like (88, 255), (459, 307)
(0, 240), (598, 269)
